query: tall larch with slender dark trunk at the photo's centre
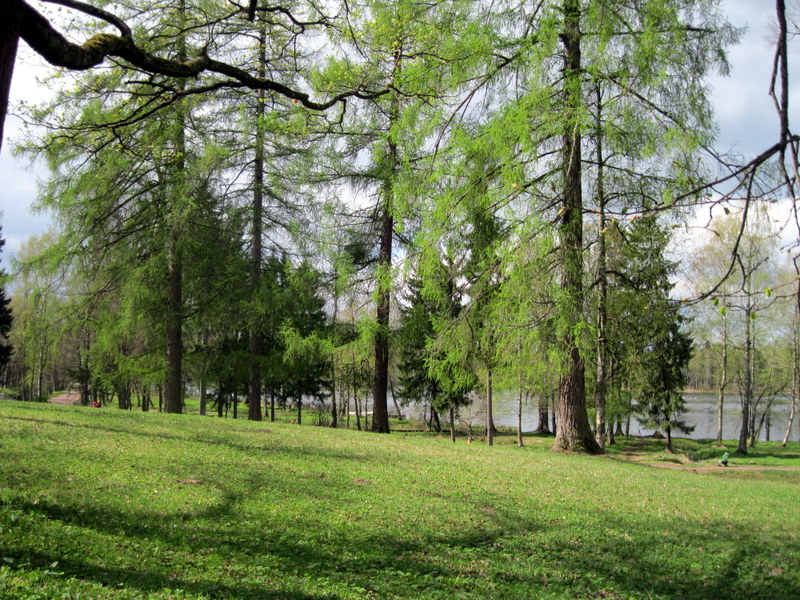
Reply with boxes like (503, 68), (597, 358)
(316, 1), (482, 433)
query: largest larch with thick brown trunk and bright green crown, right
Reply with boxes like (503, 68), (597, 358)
(446, 0), (734, 453)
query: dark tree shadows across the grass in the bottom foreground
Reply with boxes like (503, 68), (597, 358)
(3, 481), (800, 600)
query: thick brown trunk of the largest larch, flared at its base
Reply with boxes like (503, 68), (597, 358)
(553, 0), (602, 454)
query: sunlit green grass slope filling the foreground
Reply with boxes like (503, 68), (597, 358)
(0, 401), (800, 600)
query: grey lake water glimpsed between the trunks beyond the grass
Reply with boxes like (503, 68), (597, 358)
(405, 393), (800, 441)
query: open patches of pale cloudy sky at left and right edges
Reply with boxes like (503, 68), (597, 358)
(0, 0), (800, 270)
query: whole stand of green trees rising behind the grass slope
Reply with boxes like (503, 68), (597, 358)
(0, 0), (798, 453)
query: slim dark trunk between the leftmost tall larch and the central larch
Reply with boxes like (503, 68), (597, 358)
(247, 22), (267, 421)
